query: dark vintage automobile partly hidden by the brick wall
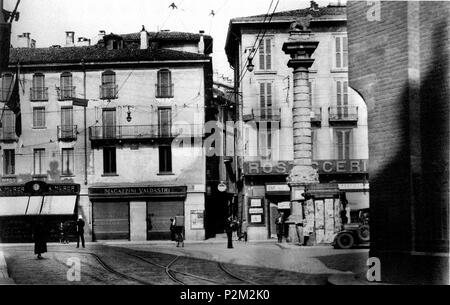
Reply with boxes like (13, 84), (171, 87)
(332, 209), (370, 249)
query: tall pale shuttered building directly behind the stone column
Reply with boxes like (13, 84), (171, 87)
(225, 1), (369, 243)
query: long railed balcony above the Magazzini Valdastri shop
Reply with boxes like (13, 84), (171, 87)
(89, 125), (204, 146)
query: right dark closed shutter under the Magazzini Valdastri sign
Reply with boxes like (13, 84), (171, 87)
(147, 201), (184, 240)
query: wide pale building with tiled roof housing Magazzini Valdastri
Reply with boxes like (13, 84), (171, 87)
(0, 29), (212, 241)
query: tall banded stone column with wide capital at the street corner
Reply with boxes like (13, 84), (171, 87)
(283, 30), (319, 243)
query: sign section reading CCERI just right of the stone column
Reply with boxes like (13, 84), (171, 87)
(312, 160), (368, 174)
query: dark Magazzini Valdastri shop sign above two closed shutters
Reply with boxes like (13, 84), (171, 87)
(89, 186), (187, 198)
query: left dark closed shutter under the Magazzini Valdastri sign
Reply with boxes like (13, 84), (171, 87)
(92, 202), (130, 240)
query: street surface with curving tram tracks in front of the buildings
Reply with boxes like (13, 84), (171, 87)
(0, 243), (367, 285)
